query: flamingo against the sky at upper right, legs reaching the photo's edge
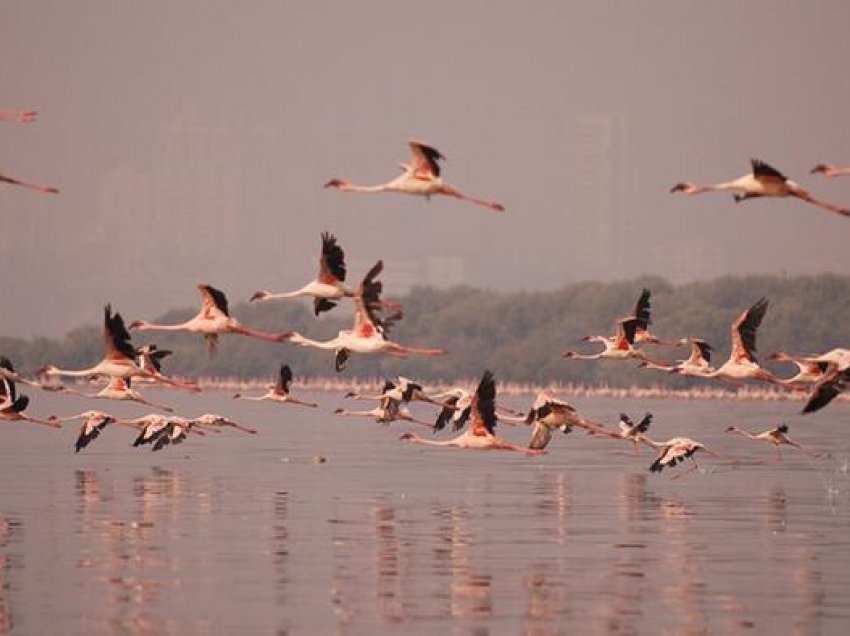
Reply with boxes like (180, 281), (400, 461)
(670, 159), (850, 216)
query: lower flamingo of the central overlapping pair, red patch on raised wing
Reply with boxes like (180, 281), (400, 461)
(290, 261), (445, 372)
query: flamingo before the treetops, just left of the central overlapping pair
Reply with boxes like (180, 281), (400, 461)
(130, 284), (291, 356)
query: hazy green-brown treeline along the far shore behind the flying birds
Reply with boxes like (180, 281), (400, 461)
(0, 274), (850, 386)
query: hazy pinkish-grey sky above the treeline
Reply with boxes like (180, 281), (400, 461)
(0, 0), (850, 336)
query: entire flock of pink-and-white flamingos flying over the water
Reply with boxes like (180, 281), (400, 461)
(0, 110), (850, 472)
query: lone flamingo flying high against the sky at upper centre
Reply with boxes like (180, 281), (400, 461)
(325, 140), (505, 212)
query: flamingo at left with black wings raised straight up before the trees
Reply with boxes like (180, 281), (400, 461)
(38, 305), (197, 390)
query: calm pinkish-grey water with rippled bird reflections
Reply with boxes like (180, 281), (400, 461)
(0, 389), (850, 635)
